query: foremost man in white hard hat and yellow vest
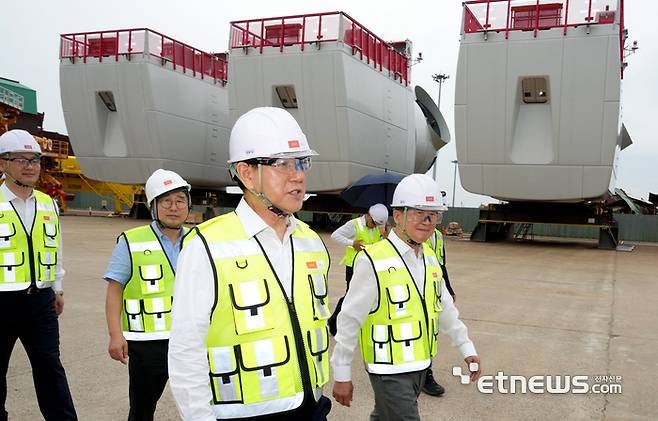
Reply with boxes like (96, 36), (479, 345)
(169, 107), (331, 421)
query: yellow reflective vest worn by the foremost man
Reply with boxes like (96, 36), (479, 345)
(191, 212), (330, 419)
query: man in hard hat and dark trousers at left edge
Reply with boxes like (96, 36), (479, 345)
(0, 130), (77, 421)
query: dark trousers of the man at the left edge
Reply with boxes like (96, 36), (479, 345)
(0, 288), (78, 421)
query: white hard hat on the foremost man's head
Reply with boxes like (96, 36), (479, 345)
(228, 107), (317, 163)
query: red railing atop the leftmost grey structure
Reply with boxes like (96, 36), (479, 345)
(59, 28), (228, 83)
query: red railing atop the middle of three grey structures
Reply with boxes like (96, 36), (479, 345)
(229, 12), (409, 85)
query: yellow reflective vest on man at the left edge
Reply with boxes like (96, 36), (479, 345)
(0, 190), (60, 291)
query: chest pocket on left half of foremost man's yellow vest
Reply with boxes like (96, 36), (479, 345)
(228, 279), (275, 335)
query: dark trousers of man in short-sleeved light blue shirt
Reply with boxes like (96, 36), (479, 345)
(128, 339), (169, 421)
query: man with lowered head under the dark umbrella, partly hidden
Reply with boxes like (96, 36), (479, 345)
(329, 203), (388, 336)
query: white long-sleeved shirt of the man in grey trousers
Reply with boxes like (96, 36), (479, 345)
(331, 230), (477, 382)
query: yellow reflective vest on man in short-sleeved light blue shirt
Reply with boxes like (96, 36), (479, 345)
(121, 225), (183, 341)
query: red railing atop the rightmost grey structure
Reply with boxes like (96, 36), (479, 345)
(463, 0), (626, 78)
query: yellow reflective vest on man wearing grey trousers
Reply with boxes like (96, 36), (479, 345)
(359, 240), (442, 374)
